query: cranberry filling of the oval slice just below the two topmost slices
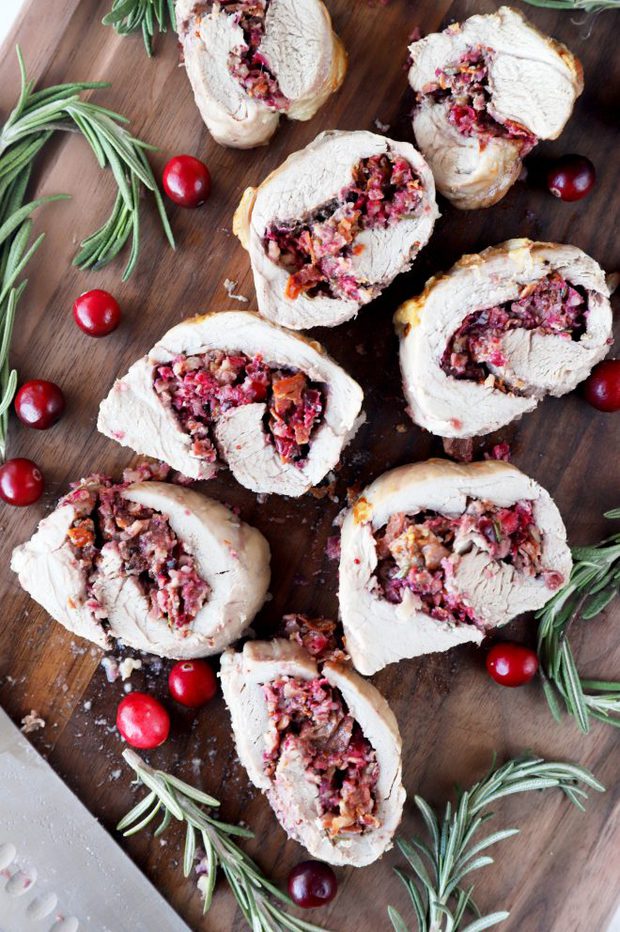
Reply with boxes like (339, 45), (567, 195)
(263, 154), (423, 303)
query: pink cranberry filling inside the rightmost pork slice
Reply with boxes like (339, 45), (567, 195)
(441, 272), (588, 392)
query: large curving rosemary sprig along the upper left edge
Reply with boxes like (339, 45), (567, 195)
(0, 48), (174, 458)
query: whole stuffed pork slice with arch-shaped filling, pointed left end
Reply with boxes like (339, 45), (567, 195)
(98, 311), (363, 496)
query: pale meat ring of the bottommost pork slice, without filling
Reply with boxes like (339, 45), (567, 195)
(220, 639), (405, 867)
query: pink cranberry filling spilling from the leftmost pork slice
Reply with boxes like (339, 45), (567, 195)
(60, 466), (210, 631)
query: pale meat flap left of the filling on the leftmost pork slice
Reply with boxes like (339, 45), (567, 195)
(11, 505), (112, 650)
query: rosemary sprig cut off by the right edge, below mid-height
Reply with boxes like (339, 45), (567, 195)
(536, 508), (620, 732)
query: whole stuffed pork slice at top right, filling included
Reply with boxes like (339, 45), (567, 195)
(409, 7), (583, 210)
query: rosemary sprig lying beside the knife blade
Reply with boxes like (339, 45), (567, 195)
(117, 749), (330, 932)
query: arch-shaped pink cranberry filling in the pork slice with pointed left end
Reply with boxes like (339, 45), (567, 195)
(154, 350), (325, 475)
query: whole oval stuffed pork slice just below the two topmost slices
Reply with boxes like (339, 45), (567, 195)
(233, 131), (438, 330)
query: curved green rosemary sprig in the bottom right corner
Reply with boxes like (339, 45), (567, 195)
(388, 757), (605, 932)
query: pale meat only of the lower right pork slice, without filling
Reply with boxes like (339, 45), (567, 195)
(339, 460), (572, 674)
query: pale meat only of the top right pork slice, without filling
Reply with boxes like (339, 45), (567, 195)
(409, 7), (583, 210)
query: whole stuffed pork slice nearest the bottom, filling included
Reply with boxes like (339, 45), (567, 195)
(220, 616), (405, 867)
